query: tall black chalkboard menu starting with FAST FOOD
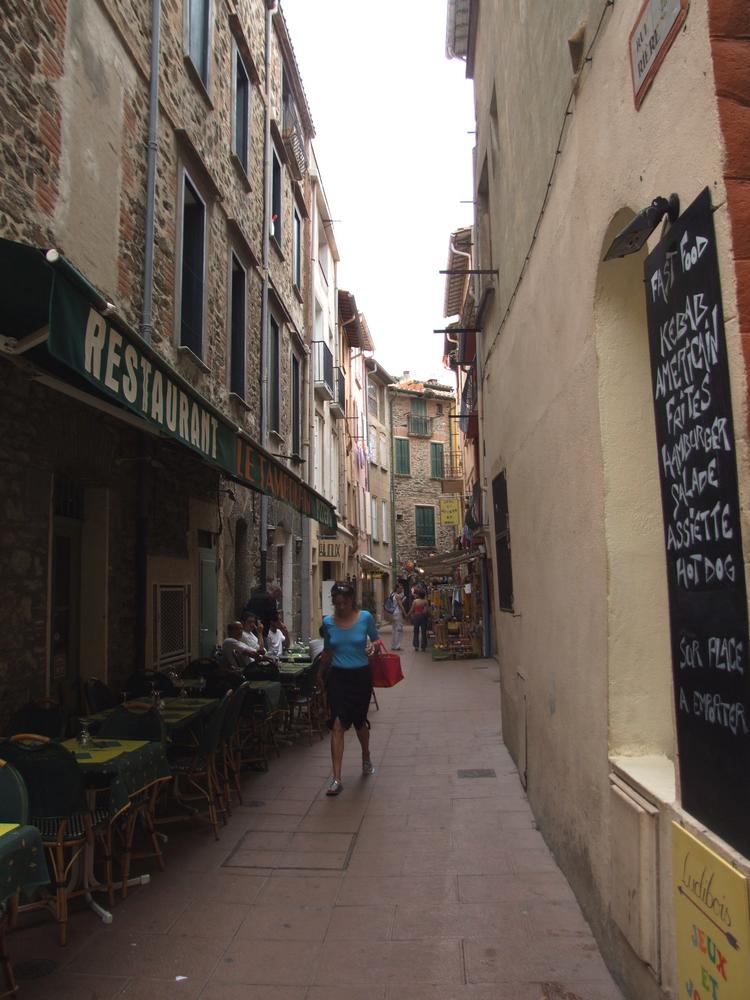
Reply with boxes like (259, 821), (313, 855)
(645, 188), (750, 855)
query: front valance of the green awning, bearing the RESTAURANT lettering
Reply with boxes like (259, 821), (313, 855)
(47, 270), (336, 530)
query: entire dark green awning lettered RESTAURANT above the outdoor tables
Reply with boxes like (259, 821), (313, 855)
(0, 239), (336, 531)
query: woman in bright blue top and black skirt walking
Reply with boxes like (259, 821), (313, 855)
(318, 581), (379, 795)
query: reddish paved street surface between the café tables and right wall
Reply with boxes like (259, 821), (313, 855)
(9, 636), (621, 1000)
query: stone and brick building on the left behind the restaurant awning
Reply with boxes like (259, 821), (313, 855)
(0, 0), (332, 736)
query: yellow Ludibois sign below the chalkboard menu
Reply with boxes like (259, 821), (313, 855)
(672, 823), (750, 1000)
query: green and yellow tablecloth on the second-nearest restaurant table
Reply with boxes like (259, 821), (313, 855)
(63, 739), (171, 813)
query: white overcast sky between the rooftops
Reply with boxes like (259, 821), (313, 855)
(281, 0), (474, 383)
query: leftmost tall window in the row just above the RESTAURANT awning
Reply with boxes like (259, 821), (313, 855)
(180, 171), (206, 358)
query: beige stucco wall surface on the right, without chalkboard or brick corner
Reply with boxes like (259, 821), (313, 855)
(475, 0), (748, 1000)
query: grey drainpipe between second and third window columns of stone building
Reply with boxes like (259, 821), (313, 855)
(260, 0), (276, 590)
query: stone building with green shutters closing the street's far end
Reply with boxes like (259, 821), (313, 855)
(388, 372), (461, 576)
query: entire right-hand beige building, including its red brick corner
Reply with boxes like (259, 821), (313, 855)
(448, 0), (750, 1000)
